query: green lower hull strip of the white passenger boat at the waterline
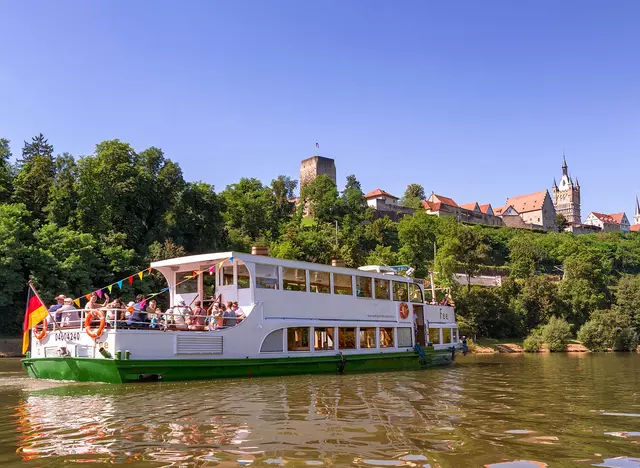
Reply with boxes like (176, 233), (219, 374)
(22, 349), (455, 383)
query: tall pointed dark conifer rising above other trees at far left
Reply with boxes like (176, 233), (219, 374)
(13, 133), (55, 219)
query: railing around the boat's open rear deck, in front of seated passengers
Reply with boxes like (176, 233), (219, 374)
(48, 307), (246, 331)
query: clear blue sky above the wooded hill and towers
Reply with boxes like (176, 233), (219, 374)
(0, 0), (640, 218)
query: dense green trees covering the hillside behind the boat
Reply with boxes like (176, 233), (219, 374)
(0, 135), (640, 342)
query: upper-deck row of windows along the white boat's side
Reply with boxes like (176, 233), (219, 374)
(222, 264), (423, 304)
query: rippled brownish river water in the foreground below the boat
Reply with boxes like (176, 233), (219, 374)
(0, 353), (640, 468)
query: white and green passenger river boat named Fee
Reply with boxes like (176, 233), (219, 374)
(22, 252), (461, 383)
